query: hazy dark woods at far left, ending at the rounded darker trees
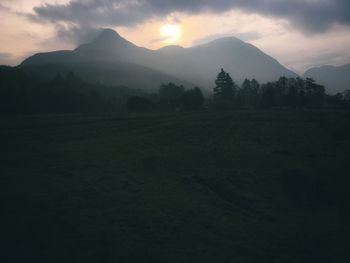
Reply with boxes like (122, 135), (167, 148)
(0, 66), (145, 114)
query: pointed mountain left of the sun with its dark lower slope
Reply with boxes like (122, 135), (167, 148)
(20, 29), (193, 92)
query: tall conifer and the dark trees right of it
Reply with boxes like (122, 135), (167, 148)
(213, 69), (350, 109)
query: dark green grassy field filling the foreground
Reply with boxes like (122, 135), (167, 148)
(0, 112), (350, 263)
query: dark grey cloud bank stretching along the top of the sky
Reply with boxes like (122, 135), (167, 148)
(31, 0), (350, 33)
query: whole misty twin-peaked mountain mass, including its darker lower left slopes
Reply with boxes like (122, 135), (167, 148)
(21, 29), (296, 92)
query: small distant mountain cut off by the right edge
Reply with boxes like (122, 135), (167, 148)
(303, 64), (350, 94)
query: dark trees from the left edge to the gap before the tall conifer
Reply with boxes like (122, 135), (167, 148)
(0, 66), (204, 114)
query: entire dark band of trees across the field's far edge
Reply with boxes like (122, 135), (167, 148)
(0, 66), (350, 114)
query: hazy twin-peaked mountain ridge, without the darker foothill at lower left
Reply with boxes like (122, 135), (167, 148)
(21, 29), (297, 91)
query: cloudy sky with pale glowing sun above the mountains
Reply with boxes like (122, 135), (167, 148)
(0, 0), (350, 73)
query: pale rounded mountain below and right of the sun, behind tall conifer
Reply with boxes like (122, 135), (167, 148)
(152, 37), (296, 88)
